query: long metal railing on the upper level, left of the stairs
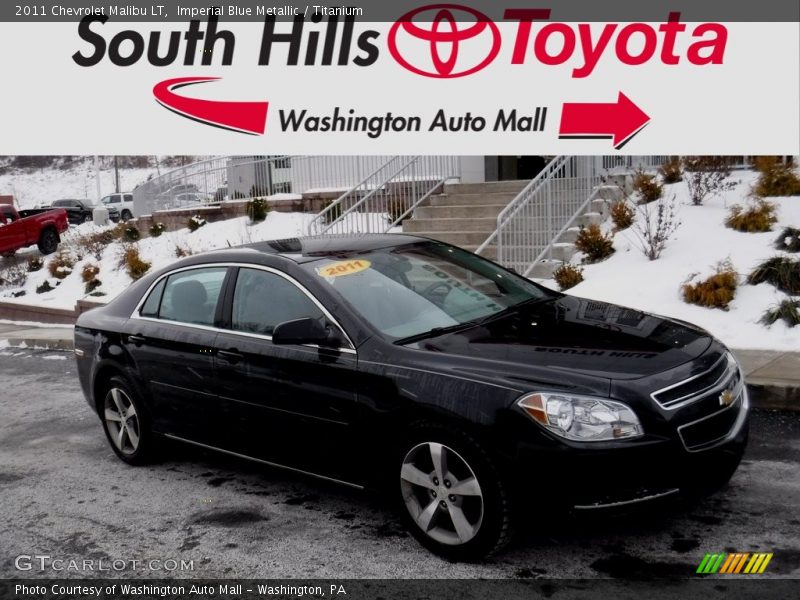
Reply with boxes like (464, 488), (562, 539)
(133, 155), (400, 216)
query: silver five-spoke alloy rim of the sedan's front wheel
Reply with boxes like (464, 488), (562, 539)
(400, 442), (484, 546)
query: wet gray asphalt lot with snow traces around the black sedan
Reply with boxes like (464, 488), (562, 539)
(0, 348), (800, 578)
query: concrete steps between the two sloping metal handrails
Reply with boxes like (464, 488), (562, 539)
(403, 181), (528, 260)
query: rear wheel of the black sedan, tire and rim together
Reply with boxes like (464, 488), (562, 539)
(97, 376), (157, 465)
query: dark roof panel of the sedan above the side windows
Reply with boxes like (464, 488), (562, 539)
(194, 233), (431, 263)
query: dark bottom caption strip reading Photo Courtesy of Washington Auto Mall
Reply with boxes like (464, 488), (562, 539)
(0, 573), (800, 600)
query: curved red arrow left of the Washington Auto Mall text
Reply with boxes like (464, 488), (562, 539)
(153, 77), (269, 135)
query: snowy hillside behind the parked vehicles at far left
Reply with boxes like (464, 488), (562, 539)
(0, 159), (158, 210)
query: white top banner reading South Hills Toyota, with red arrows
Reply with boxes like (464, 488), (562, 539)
(0, 0), (800, 155)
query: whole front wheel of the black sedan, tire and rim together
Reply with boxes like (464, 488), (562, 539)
(394, 425), (512, 561)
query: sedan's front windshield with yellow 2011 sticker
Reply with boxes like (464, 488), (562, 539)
(303, 242), (550, 340)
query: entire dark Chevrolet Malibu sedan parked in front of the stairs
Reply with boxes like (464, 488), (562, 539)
(75, 235), (748, 559)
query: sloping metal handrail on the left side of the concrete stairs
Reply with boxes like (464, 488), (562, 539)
(308, 156), (461, 235)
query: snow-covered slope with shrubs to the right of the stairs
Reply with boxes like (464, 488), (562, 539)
(556, 171), (800, 351)
